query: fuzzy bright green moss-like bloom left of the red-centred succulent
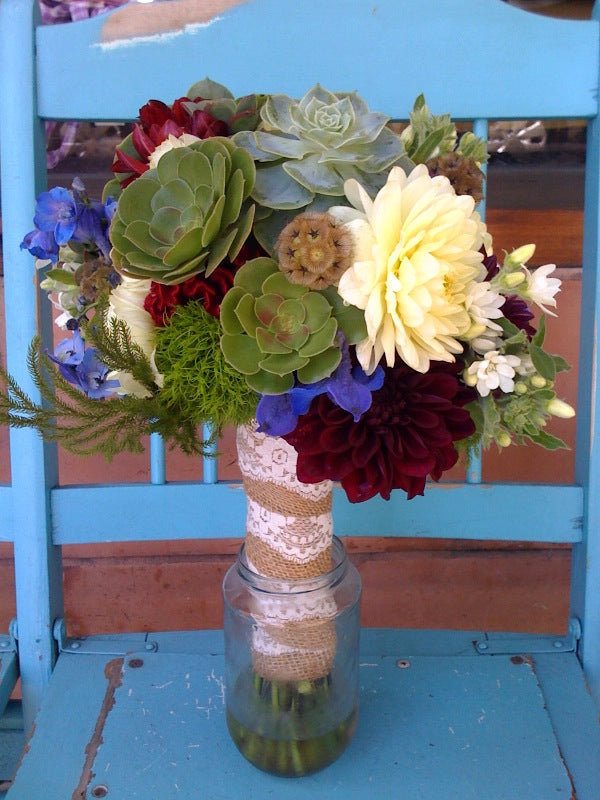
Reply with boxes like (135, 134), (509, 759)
(155, 302), (256, 434)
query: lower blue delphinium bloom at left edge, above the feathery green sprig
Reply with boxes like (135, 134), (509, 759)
(47, 329), (119, 400)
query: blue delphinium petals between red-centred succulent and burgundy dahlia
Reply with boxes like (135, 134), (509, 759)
(256, 334), (384, 436)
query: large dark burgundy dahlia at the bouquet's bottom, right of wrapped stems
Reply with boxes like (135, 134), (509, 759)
(284, 362), (475, 503)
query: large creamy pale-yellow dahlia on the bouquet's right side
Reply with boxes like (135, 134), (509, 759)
(329, 165), (489, 374)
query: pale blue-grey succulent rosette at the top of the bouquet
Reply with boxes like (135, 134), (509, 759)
(233, 84), (412, 252)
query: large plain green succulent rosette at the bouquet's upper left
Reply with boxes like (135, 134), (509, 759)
(110, 137), (256, 284)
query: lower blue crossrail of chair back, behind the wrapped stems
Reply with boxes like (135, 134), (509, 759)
(52, 483), (582, 544)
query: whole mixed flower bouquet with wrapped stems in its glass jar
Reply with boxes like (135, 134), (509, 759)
(0, 79), (573, 775)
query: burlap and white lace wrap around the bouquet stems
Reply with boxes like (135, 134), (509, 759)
(237, 425), (336, 680)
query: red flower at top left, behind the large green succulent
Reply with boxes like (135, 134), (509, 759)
(111, 97), (229, 188)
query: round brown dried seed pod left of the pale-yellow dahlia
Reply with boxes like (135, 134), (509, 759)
(277, 211), (353, 289)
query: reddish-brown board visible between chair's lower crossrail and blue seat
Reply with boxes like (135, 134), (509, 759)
(62, 539), (570, 636)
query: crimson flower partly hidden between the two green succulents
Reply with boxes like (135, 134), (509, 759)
(144, 264), (235, 327)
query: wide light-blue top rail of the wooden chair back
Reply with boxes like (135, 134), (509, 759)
(37, 0), (598, 119)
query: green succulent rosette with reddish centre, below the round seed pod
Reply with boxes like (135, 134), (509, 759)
(221, 258), (366, 395)
